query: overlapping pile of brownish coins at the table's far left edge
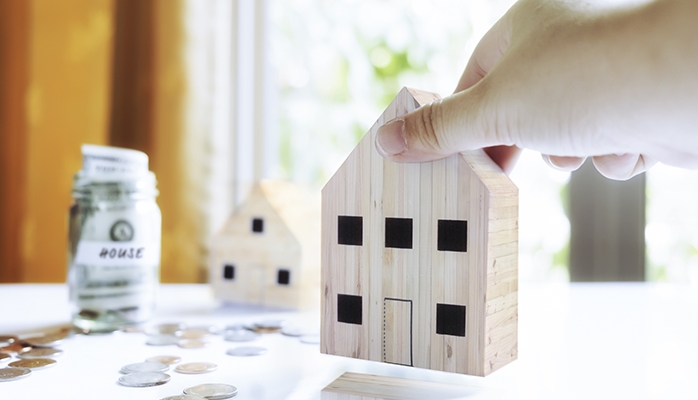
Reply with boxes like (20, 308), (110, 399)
(0, 328), (71, 382)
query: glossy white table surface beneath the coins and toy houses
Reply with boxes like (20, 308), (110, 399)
(0, 283), (698, 400)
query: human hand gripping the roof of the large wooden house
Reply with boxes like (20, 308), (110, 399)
(376, 0), (698, 179)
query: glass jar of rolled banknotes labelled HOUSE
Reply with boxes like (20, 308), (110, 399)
(68, 145), (161, 332)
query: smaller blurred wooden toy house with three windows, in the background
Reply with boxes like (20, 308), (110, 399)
(209, 181), (320, 308)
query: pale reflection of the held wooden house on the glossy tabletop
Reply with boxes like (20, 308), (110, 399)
(321, 372), (477, 400)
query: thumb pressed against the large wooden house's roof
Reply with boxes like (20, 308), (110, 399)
(376, 85), (494, 162)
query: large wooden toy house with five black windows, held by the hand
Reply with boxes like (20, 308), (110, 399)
(321, 88), (518, 376)
